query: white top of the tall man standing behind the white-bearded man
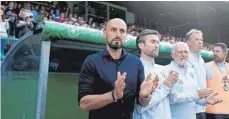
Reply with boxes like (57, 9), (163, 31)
(189, 52), (207, 113)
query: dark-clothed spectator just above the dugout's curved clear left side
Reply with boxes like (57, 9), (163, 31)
(16, 10), (34, 38)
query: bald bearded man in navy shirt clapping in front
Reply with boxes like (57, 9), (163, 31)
(78, 18), (158, 119)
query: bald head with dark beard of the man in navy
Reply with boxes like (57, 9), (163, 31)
(103, 18), (127, 50)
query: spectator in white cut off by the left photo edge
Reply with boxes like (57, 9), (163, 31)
(0, 8), (9, 38)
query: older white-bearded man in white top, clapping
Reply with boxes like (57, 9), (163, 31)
(163, 42), (221, 119)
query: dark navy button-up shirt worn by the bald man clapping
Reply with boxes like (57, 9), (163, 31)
(78, 48), (145, 119)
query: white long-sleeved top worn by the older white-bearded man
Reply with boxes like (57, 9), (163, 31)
(164, 61), (200, 119)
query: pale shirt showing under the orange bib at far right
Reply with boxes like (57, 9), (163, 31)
(205, 62), (227, 80)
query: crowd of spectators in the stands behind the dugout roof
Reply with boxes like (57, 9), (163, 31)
(0, 1), (213, 50)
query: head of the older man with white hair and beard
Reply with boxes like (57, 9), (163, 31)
(171, 42), (189, 65)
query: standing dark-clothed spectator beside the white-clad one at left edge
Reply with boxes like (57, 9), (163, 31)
(5, 2), (17, 36)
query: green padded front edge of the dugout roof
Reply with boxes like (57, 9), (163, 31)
(40, 21), (213, 60)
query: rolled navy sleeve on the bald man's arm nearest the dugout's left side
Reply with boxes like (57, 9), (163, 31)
(78, 55), (95, 102)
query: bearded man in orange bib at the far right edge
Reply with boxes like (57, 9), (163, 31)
(206, 43), (229, 119)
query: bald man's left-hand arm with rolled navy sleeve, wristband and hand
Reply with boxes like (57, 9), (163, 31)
(78, 56), (127, 111)
